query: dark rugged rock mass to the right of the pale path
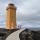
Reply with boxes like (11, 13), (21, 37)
(19, 29), (40, 40)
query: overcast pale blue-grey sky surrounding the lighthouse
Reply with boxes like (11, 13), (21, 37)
(0, 0), (40, 28)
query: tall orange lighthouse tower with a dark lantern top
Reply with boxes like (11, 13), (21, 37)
(6, 3), (16, 29)
